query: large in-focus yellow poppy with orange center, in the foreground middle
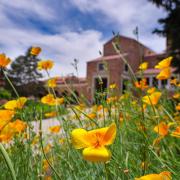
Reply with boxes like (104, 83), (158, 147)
(71, 123), (116, 162)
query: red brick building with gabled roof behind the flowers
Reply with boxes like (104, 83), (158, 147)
(58, 36), (179, 103)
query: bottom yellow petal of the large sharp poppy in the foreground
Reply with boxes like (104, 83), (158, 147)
(83, 147), (111, 162)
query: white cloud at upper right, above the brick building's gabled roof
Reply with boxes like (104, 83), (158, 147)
(71, 0), (165, 52)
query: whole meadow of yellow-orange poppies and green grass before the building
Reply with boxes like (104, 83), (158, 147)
(0, 42), (180, 180)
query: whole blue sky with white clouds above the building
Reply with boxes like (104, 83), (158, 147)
(0, 0), (166, 77)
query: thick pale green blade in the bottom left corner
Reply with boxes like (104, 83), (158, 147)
(0, 143), (16, 180)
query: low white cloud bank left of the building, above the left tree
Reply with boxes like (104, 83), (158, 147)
(0, 29), (104, 76)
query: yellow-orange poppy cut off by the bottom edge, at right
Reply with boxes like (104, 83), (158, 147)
(135, 171), (171, 180)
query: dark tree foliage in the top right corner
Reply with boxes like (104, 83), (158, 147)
(149, 0), (180, 71)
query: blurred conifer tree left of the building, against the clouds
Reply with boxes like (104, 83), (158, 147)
(8, 47), (43, 86)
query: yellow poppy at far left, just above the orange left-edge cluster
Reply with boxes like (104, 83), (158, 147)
(4, 97), (27, 110)
